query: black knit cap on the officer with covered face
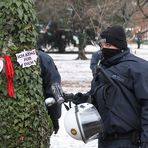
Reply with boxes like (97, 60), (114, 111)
(100, 25), (128, 50)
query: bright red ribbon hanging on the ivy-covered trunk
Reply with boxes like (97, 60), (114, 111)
(3, 55), (14, 97)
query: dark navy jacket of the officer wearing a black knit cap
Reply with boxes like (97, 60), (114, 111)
(90, 51), (148, 143)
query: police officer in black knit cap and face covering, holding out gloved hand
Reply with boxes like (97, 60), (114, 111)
(65, 26), (148, 148)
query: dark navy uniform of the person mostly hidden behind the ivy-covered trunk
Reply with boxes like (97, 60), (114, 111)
(38, 50), (61, 133)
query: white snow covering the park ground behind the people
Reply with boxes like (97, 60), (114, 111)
(50, 44), (148, 148)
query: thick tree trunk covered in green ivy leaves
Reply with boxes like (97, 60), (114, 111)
(0, 0), (52, 148)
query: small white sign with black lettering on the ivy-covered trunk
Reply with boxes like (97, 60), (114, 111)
(16, 49), (37, 68)
